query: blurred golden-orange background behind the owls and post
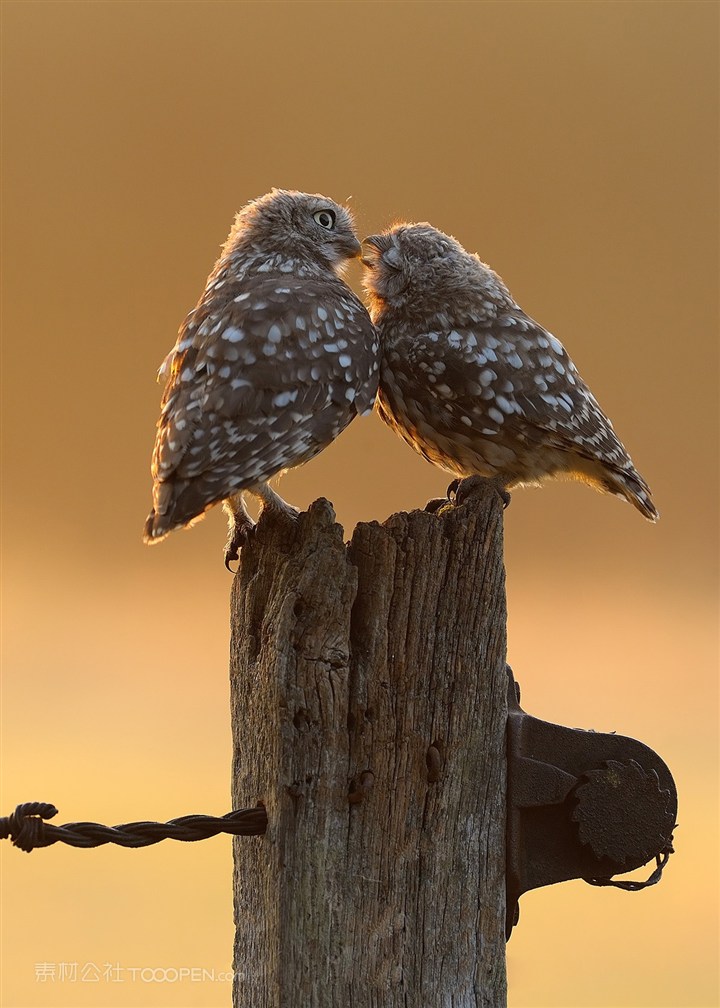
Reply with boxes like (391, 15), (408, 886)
(0, 0), (718, 1008)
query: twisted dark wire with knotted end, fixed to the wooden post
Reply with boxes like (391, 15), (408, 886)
(0, 801), (267, 853)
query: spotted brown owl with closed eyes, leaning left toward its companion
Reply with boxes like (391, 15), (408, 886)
(362, 224), (658, 521)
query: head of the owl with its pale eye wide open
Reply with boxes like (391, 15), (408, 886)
(223, 188), (361, 271)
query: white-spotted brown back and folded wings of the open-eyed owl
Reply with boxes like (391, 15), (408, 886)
(152, 273), (378, 523)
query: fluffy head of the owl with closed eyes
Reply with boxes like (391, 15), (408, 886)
(362, 224), (507, 317)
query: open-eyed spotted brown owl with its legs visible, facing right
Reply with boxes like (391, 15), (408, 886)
(143, 190), (379, 565)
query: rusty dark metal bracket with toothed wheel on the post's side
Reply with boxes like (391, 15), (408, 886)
(505, 665), (678, 937)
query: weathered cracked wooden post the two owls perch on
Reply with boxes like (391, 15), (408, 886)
(231, 490), (507, 1008)
